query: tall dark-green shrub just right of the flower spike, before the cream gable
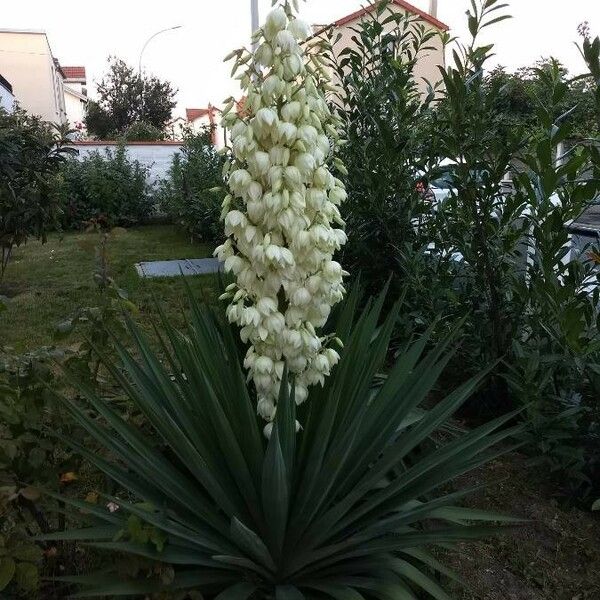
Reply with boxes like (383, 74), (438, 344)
(324, 3), (446, 304)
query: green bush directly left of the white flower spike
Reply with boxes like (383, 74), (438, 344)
(158, 129), (224, 243)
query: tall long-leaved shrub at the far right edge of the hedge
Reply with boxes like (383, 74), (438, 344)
(507, 62), (600, 489)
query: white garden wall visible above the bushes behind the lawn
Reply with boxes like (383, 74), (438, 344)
(73, 140), (183, 183)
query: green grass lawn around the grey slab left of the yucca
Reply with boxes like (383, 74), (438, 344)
(0, 225), (217, 353)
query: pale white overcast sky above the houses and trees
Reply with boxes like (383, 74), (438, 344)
(0, 0), (600, 115)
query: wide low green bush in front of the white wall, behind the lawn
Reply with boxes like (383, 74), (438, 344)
(61, 145), (154, 228)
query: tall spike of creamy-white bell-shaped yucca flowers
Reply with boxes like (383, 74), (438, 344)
(215, 2), (346, 421)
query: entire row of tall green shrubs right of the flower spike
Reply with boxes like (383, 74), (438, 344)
(328, 0), (600, 493)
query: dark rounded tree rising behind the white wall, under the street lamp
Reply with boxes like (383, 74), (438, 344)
(85, 57), (177, 138)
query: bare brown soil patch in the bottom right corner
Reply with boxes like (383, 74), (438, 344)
(442, 453), (600, 600)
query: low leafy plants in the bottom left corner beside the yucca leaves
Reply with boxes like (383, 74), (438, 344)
(0, 348), (84, 598)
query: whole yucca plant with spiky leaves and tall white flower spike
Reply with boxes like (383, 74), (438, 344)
(39, 0), (518, 600)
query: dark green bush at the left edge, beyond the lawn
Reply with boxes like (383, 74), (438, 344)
(0, 108), (73, 277)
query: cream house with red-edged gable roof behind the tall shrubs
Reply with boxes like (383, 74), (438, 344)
(313, 0), (449, 94)
